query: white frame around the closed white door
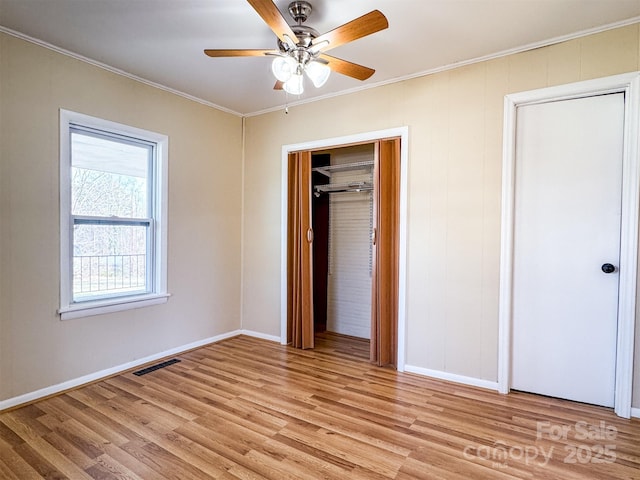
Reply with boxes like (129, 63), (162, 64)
(498, 72), (640, 418)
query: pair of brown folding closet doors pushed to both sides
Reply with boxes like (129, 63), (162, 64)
(287, 138), (400, 367)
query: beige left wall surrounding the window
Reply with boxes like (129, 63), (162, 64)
(0, 34), (242, 400)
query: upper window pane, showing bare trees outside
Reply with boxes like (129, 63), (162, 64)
(71, 132), (152, 218)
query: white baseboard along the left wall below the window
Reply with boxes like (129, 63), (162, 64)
(0, 330), (241, 412)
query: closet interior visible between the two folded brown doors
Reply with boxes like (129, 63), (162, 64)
(311, 143), (375, 359)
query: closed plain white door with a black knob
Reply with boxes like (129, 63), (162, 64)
(511, 93), (624, 407)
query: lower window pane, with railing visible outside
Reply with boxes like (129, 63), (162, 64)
(73, 225), (150, 301)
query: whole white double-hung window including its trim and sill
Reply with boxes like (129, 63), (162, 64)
(59, 110), (168, 319)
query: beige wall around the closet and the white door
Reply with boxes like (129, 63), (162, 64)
(243, 21), (640, 406)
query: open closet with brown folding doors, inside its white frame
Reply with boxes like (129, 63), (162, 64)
(283, 137), (401, 367)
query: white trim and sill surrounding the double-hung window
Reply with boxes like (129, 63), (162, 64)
(58, 109), (170, 320)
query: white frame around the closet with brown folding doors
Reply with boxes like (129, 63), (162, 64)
(280, 126), (409, 372)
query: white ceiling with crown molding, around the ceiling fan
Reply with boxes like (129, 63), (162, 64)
(0, 0), (640, 115)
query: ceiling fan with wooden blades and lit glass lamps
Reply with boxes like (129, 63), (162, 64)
(204, 0), (389, 95)
